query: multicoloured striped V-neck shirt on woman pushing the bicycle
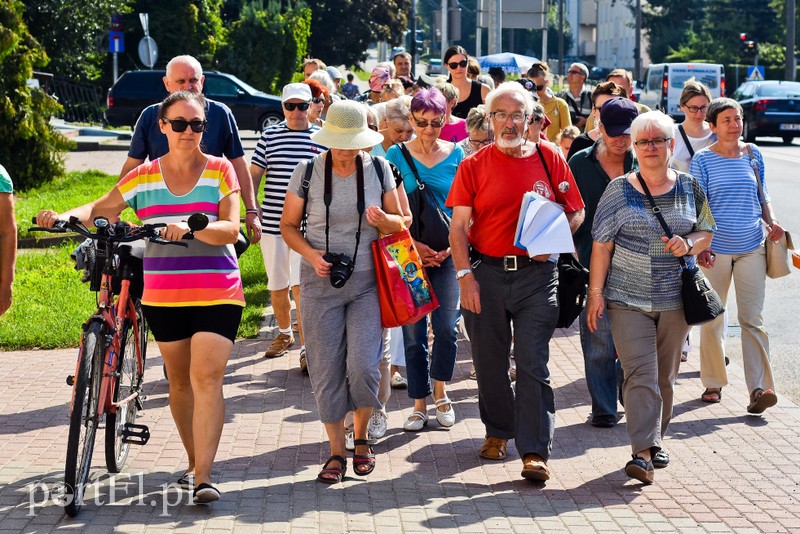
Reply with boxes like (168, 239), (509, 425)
(117, 156), (244, 307)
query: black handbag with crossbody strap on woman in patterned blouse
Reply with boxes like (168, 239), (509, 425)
(636, 173), (725, 326)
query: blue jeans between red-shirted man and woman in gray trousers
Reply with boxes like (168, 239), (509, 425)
(580, 309), (617, 420)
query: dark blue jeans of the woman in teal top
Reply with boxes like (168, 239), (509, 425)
(403, 258), (459, 399)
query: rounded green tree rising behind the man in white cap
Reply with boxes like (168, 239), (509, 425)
(219, 0), (311, 93)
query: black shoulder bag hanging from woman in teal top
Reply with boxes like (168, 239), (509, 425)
(400, 143), (450, 251)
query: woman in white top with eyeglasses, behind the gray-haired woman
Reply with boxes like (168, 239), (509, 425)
(671, 78), (717, 172)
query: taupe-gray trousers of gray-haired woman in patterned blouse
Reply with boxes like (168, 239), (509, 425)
(608, 302), (689, 454)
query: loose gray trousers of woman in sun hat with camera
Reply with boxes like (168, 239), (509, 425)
(300, 262), (383, 423)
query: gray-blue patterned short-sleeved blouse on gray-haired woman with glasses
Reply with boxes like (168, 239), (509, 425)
(592, 172), (714, 312)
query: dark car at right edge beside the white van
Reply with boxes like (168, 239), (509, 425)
(733, 80), (800, 145)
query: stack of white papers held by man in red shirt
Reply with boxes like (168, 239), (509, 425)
(514, 191), (575, 258)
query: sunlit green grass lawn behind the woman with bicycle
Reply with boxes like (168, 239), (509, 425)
(0, 172), (269, 350)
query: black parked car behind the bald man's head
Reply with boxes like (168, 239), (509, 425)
(104, 70), (283, 132)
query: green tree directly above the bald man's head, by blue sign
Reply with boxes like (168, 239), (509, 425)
(125, 0), (226, 69)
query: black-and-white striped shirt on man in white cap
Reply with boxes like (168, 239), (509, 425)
(250, 121), (327, 235)
